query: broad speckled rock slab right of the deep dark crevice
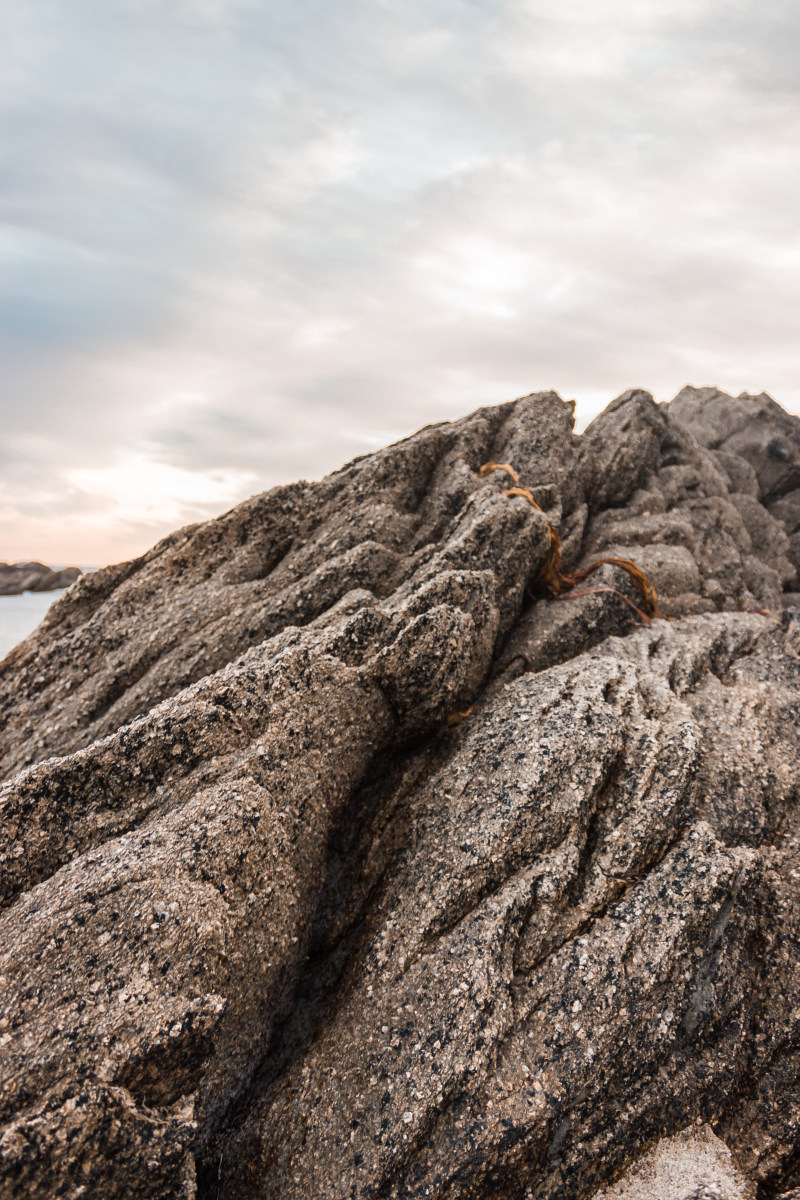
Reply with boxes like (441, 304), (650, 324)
(212, 616), (800, 1196)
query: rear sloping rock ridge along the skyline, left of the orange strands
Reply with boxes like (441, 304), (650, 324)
(0, 394), (563, 773)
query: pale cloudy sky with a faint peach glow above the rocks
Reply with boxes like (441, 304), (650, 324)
(0, 0), (800, 565)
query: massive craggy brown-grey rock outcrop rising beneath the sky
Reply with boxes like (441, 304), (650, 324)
(0, 389), (800, 1200)
